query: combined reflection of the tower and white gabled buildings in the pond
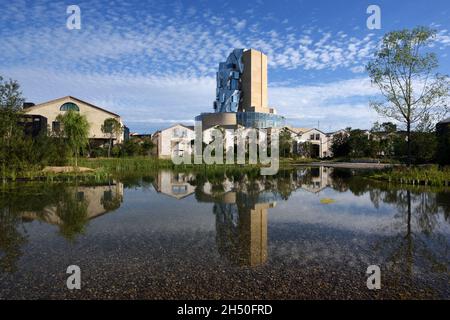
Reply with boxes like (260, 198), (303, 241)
(150, 167), (333, 266)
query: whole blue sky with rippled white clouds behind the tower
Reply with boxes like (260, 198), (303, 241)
(0, 0), (450, 133)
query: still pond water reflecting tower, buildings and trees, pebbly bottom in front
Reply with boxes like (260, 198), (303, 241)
(0, 167), (450, 299)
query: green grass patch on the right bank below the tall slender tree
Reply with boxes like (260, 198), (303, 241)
(370, 165), (450, 187)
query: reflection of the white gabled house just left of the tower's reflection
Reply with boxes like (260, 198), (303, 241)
(153, 170), (195, 199)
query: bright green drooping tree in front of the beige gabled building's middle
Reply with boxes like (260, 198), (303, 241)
(56, 110), (89, 167)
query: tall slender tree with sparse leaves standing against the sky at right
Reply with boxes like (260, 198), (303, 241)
(366, 27), (450, 165)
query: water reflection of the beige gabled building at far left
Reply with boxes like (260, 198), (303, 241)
(22, 183), (123, 225)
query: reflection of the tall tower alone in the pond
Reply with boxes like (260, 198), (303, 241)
(213, 192), (275, 266)
